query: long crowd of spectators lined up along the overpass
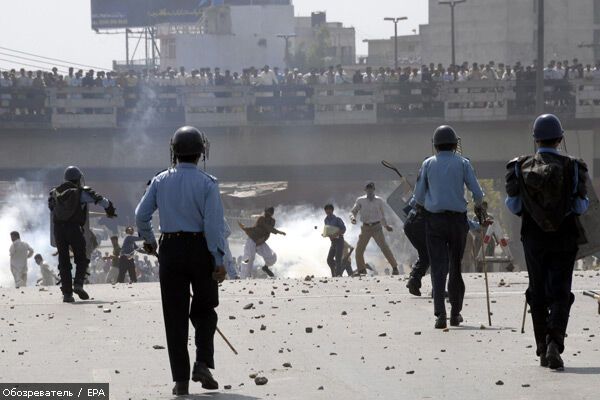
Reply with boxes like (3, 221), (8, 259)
(0, 59), (600, 118)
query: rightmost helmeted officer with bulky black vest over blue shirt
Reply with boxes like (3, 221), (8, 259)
(506, 114), (589, 370)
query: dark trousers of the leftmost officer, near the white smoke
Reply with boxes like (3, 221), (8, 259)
(54, 222), (90, 294)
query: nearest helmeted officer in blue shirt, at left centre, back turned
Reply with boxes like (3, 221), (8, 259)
(135, 126), (226, 395)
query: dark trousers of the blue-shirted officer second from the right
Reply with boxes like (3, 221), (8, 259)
(426, 212), (469, 316)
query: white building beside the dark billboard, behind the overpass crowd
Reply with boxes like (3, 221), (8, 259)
(158, 0), (294, 71)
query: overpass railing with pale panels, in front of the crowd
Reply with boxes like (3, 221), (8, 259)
(0, 80), (600, 129)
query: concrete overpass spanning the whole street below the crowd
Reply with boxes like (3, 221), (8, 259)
(0, 81), (600, 182)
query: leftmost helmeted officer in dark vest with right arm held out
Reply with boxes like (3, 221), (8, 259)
(48, 166), (117, 303)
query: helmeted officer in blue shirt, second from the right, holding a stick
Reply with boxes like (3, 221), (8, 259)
(414, 125), (483, 329)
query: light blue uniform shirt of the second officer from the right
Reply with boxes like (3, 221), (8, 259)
(414, 151), (483, 213)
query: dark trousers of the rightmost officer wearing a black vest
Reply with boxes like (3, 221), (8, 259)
(521, 222), (578, 355)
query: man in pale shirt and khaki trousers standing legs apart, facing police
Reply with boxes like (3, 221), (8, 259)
(350, 182), (400, 275)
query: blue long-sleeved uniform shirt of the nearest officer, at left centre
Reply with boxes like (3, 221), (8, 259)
(135, 163), (225, 266)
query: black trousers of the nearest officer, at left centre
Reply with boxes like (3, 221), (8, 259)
(158, 234), (219, 382)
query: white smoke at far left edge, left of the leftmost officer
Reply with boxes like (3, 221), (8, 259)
(0, 180), (56, 287)
